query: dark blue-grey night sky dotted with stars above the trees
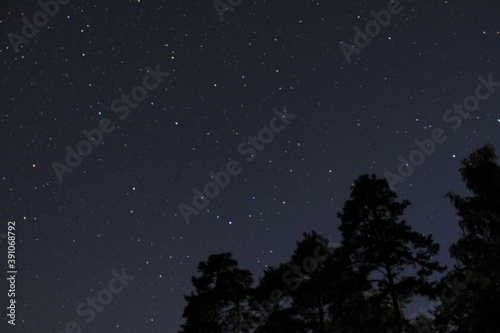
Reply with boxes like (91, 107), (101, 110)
(0, 0), (500, 333)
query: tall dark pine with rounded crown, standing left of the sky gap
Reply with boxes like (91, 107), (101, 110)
(338, 175), (445, 333)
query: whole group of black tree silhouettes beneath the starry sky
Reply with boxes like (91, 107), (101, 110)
(179, 144), (500, 333)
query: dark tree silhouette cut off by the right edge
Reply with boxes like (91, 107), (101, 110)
(436, 144), (500, 333)
